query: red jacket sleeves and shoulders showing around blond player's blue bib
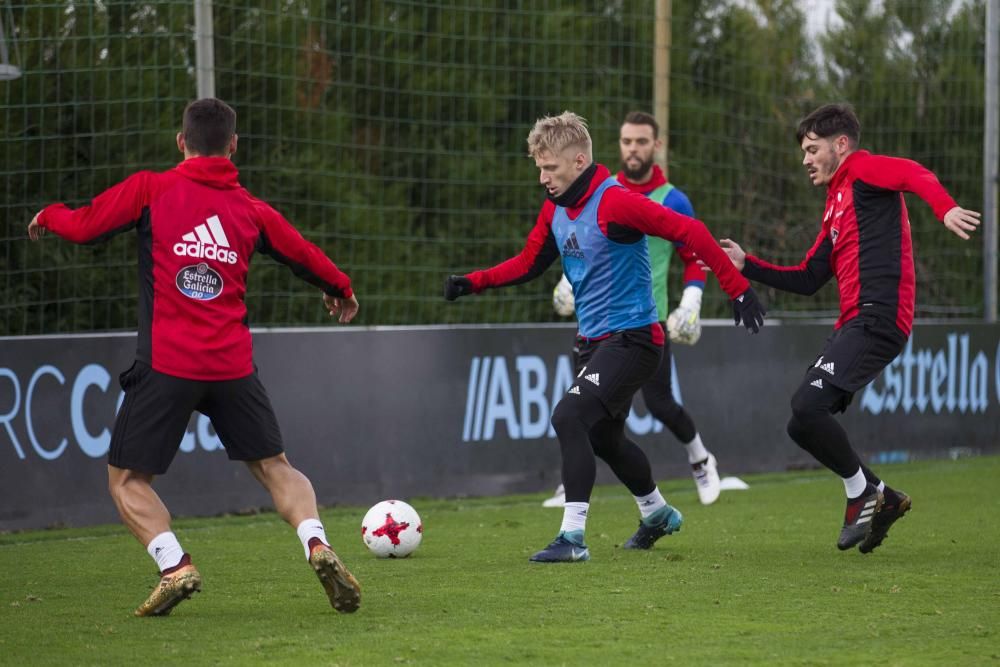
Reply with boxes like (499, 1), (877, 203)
(466, 165), (750, 299)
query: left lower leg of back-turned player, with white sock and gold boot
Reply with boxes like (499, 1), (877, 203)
(108, 466), (201, 616)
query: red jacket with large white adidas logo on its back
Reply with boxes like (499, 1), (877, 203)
(38, 157), (352, 380)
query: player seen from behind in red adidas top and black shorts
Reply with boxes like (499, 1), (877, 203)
(28, 98), (361, 616)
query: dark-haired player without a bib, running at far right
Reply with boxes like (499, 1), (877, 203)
(722, 104), (979, 553)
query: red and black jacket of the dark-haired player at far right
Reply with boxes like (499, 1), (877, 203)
(743, 151), (956, 336)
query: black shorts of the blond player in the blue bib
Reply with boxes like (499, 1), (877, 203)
(569, 328), (663, 419)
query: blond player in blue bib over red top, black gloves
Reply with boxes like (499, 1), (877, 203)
(444, 111), (764, 562)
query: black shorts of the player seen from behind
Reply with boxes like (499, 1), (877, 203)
(108, 361), (284, 475)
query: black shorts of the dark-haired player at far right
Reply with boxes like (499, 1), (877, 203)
(806, 313), (906, 394)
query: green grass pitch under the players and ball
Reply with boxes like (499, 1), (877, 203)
(0, 457), (1000, 666)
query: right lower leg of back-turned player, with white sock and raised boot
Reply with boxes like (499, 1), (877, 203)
(247, 454), (361, 613)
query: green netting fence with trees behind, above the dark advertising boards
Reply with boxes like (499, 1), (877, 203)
(0, 0), (985, 335)
